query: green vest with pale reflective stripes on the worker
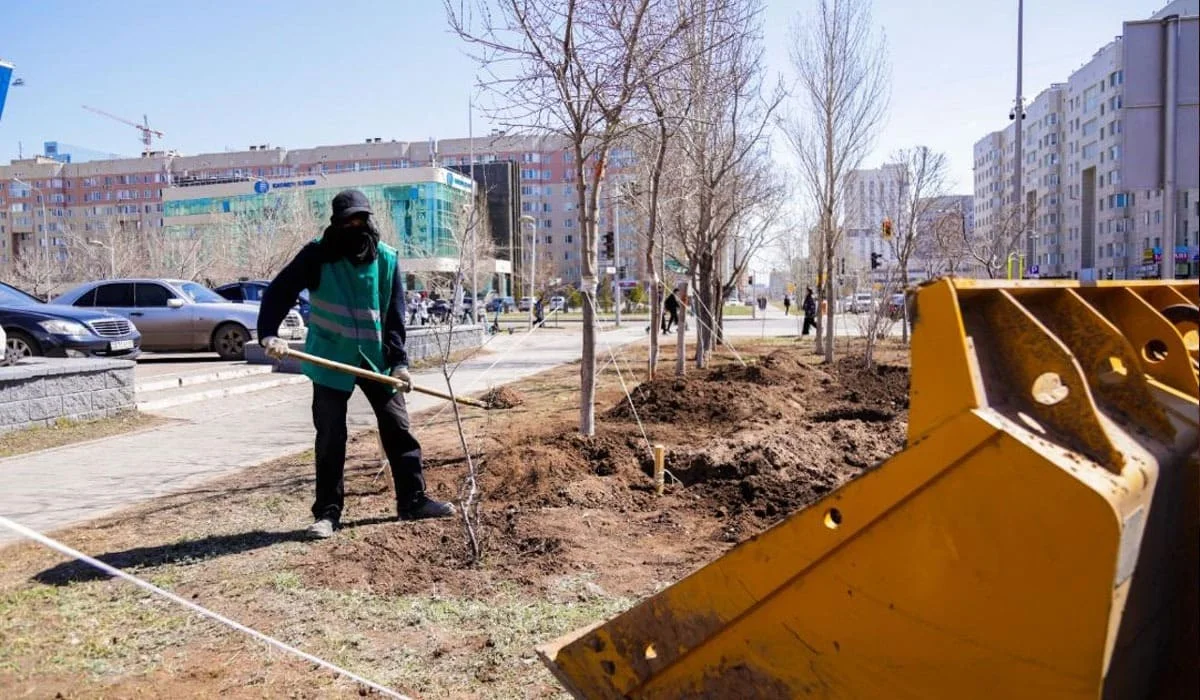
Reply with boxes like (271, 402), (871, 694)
(304, 243), (396, 391)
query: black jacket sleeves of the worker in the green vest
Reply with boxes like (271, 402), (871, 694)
(258, 241), (408, 367)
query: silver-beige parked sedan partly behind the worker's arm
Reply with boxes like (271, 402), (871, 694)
(55, 280), (305, 360)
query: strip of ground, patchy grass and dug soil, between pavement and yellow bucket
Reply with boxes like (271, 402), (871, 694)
(0, 342), (908, 698)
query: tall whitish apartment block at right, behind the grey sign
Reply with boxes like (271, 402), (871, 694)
(974, 0), (1200, 280)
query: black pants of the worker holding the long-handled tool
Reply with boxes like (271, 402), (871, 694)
(312, 379), (425, 522)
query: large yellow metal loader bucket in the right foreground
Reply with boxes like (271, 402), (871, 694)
(539, 280), (1200, 699)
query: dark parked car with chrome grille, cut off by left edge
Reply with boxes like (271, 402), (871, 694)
(0, 282), (142, 364)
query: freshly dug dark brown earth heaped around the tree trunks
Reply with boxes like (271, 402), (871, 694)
(304, 347), (908, 594)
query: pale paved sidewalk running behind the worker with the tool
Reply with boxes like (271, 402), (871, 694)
(0, 325), (646, 544)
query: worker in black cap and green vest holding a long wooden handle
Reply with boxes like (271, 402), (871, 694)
(258, 190), (455, 539)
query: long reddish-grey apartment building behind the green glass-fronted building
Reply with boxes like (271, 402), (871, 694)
(0, 133), (644, 290)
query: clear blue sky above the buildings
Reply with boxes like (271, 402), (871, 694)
(0, 0), (1165, 192)
